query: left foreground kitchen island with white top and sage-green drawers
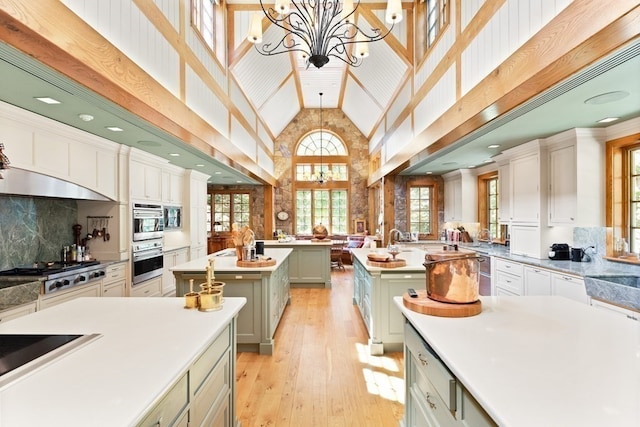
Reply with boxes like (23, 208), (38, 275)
(0, 298), (245, 427)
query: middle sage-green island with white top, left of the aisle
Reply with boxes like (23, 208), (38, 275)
(170, 248), (292, 354)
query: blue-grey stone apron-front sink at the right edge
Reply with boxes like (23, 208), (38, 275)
(584, 274), (640, 311)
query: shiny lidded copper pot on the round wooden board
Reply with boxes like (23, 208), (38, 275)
(423, 250), (481, 304)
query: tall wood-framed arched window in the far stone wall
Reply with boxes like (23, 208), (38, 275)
(293, 129), (349, 234)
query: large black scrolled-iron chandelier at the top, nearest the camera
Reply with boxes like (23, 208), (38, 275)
(247, 0), (402, 68)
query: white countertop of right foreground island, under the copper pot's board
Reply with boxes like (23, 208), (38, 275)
(394, 297), (640, 427)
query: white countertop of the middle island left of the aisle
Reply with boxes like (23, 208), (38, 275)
(169, 248), (292, 275)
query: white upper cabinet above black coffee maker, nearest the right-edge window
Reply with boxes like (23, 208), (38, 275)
(546, 129), (606, 227)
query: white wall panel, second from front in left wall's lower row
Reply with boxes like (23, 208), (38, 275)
(185, 67), (229, 137)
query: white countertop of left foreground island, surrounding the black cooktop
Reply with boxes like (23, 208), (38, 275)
(0, 298), (246, 427)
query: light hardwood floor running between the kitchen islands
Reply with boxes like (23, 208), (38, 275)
(236, 266), (404, 427)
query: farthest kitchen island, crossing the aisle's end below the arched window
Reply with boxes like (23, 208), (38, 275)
(264, 239), (332, 288)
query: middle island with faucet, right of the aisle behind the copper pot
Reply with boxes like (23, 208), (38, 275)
(351, 248), (426, 355)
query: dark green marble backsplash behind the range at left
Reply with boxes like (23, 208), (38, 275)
(0, 194), (78, 270)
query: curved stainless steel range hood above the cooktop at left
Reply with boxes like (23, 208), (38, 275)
(0, 167), (111, 201)
